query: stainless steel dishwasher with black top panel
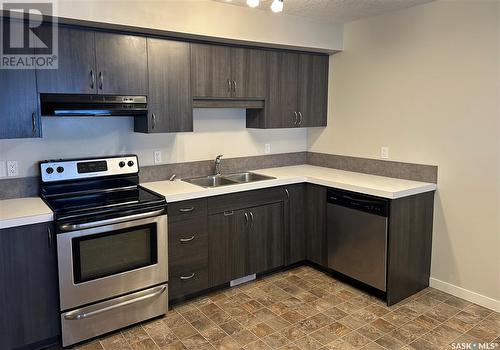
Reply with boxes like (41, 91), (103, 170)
(327, 189), (389, 291)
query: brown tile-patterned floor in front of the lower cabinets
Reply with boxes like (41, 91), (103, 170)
(64, 267), (500, 350)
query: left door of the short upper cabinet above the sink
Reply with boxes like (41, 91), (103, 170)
(191, 44), (232, 98)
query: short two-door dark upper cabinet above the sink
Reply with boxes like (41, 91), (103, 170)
(191, 44), (267, 100)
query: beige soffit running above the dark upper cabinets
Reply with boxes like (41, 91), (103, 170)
(52, 0), (343, 50)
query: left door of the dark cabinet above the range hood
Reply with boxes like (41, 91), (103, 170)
(36, 27), (97, 94)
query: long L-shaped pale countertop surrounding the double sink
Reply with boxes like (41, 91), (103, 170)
(142, 165), (437, 203)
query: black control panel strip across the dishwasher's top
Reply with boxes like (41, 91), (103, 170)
(327, 189), (389, 217)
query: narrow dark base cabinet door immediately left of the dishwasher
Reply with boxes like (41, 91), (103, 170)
(305, 184), (328, 266)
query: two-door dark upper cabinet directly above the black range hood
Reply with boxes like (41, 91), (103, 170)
(37, 27), (148, 95)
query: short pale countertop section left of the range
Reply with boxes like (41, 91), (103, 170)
(0, 197), (53, 229)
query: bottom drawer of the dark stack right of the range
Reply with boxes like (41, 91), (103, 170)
(168, 263), (208, 299)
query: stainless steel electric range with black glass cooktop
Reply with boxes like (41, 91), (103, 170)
(40, 155), (168, 346)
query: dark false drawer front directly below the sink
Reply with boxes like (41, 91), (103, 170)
(208, 187), (283, 214)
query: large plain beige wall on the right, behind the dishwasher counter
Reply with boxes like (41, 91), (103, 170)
(308, 0), (500, 305)
